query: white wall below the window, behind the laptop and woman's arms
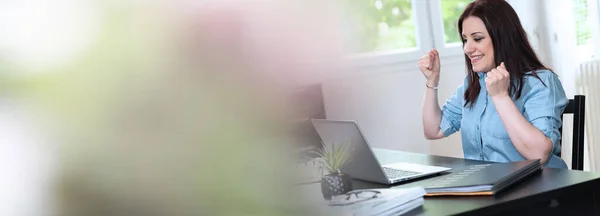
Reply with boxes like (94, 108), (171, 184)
(323, 56), (465, 157)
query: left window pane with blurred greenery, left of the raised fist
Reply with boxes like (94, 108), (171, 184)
(345, 0), (433, 66)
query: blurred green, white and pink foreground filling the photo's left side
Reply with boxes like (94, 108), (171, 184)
(0, 0), (356, 216)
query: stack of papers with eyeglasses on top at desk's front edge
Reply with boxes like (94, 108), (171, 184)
(328, 187), (425, 216)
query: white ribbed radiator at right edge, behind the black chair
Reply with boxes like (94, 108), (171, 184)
(575, 59), (600, 171)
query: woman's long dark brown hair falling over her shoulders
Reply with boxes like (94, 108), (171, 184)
(458, 0), (551, 108)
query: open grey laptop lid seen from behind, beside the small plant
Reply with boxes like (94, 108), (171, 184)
(311, 119), (390, 184)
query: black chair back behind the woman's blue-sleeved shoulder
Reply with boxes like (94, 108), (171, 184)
(558, 95), (585, 170)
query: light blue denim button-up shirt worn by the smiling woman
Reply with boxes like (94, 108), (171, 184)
(440, 70), (569, 168)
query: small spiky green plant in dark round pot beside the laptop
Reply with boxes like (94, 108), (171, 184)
(317, 143), (352, 200)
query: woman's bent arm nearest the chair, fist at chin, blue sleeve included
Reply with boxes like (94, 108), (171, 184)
(486, 64), (568, 163)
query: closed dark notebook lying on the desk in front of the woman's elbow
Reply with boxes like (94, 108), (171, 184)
(425, 160), (542, 196)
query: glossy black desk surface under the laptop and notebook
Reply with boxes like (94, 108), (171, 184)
(354, 149), (600, 216)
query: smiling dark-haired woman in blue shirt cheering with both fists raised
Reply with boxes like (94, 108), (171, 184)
(419, 0), (568, 168)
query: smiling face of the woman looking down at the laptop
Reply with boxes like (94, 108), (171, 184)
(462, 16), (496, 72)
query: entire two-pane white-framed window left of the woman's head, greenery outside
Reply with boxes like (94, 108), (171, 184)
(347, 0), (473, 66)
